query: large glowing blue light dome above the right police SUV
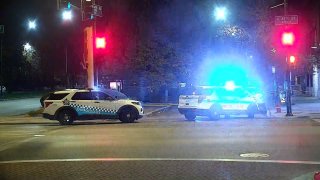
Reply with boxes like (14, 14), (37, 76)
(195, 54), (263, 90)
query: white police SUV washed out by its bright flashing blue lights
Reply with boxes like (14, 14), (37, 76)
(178, 81), (267, 120)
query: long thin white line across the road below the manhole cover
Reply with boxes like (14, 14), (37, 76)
(0, 158), (320, 165)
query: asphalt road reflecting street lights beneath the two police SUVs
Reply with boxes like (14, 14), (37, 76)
(0, 108), (320, 180)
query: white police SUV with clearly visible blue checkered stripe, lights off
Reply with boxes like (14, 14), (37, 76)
(43, 89), (143, 125)
